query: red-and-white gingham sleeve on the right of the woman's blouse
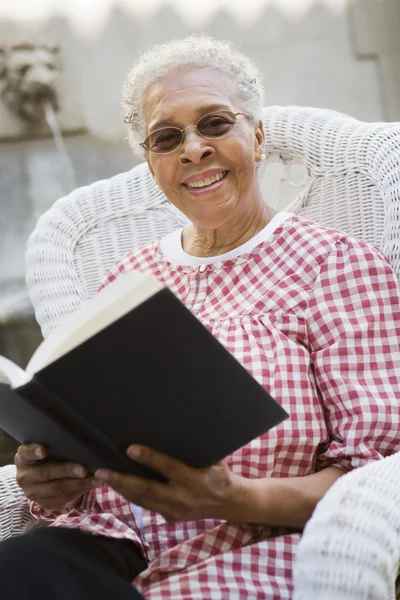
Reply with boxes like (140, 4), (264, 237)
(306, 238), (400, 471)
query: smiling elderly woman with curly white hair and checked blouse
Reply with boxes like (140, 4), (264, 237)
(0, 36), (400, 600)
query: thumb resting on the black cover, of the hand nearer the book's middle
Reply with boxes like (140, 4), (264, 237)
(127, 445), (195, 485)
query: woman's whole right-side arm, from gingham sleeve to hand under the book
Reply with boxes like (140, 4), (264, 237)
(96, 238), (400, 528)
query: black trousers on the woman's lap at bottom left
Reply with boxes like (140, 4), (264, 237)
(0, 527), (147, 600)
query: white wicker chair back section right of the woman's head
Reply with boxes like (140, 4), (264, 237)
(263, 107), (400, 277)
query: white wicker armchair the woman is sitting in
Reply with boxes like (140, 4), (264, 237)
(0, 107), (400, 600)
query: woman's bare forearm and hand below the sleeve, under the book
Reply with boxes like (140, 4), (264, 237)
(96, 446), (343, 529)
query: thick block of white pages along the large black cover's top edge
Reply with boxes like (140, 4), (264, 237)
(26, 271), (164, 378)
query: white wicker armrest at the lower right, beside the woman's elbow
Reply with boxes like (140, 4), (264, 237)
(293, 453), (400, 600)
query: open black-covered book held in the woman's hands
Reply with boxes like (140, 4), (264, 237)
(0, 271), (288, 478)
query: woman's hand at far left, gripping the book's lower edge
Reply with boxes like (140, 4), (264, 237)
(14, 444), (102, 513)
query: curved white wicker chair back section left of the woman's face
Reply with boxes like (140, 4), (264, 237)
(26, 164), (187, 337)
